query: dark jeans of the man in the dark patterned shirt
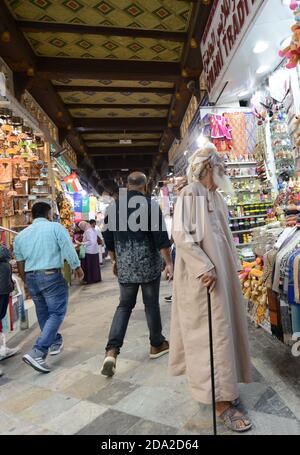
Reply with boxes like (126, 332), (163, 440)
(106, 276), (165, 354)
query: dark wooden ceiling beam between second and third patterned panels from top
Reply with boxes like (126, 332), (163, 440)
(37, 57), (180, 82)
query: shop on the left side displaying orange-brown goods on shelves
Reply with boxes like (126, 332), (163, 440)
(0, 58), (52, 342)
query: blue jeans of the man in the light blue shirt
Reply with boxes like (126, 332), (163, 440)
(26, 272), (69, 357)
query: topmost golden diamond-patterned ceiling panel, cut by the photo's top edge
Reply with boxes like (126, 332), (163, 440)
(5, 0), (192, 32)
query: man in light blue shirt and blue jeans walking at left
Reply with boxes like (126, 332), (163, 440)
(14, 202), (84, 373)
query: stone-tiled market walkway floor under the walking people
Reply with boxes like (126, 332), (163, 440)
(0, 265), (300, 435)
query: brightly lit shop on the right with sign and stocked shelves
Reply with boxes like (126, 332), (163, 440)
(166, 0), (300, 343)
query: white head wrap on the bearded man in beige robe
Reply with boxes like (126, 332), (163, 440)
(187, 142), (223, 183)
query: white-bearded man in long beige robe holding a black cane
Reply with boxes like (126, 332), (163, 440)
(169, 143), (251, 431)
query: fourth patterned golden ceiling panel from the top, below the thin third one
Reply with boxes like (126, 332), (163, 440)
(60, 91), (172, 108)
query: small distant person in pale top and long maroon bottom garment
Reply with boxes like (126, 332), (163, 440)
(79, 221), (101, 284)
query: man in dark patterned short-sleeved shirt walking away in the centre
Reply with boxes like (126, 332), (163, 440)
(101, 172), (173, 376)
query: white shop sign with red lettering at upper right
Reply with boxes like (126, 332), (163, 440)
(200, 0), (263, 93)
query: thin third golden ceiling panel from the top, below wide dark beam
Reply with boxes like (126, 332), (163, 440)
(52, 79), (174, 89)
